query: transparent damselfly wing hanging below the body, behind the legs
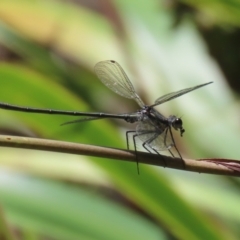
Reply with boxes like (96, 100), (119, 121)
(136, 121), (174, 151)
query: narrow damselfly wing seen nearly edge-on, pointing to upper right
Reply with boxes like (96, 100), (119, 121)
(151, 82), (212, 107)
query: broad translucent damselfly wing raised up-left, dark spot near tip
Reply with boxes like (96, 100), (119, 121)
(94, 60), (145, 107)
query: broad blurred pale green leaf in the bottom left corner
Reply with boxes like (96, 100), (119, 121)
(0, 172), (165, 240)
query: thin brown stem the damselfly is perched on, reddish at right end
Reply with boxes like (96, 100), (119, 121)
(0, 135), (240, 176)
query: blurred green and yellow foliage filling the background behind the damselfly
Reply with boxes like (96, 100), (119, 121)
(0, 0), (240, 240)
